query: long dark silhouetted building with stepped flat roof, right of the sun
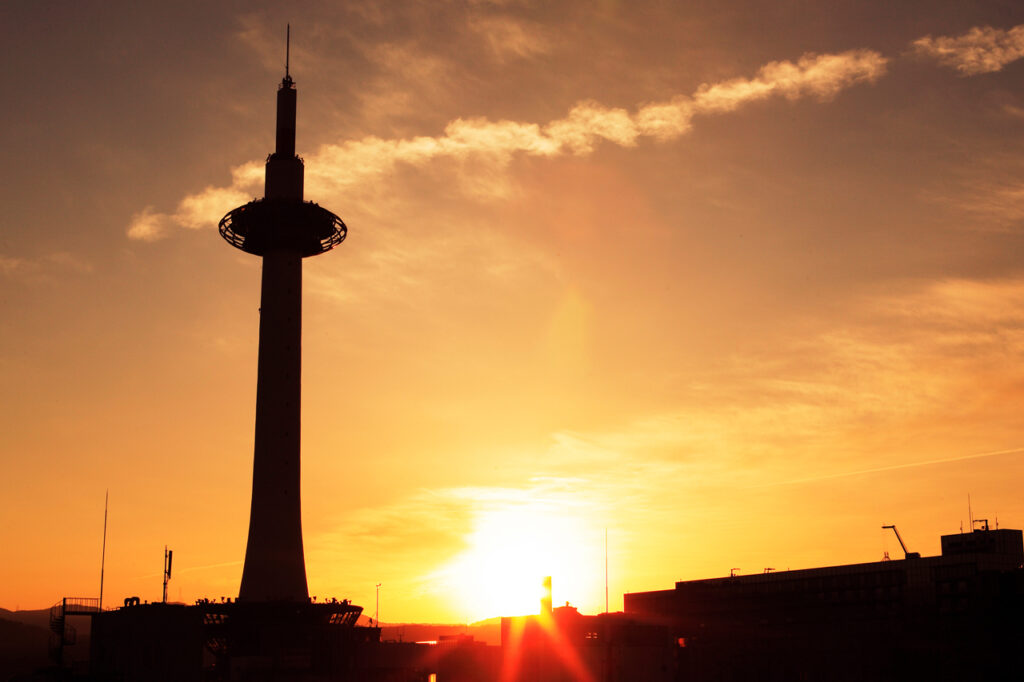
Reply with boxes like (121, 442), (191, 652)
(625, 525), (1024, 681)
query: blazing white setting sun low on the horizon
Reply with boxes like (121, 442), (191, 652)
(432, 503), (603, 621)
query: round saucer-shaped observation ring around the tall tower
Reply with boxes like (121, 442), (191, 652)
(217, 199), (348, 258)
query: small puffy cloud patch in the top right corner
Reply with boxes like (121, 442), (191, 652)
(912, 24), (1024, 76)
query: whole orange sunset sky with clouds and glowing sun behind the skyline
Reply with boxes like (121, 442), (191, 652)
(0, 0), (1024, 622)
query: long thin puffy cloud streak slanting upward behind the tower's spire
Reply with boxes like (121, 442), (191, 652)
(128, 50), (887, 236)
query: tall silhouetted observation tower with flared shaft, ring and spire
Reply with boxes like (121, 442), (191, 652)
(218, 33), (347, 602)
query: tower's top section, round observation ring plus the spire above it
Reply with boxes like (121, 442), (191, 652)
(218, 25), (348, 257)
